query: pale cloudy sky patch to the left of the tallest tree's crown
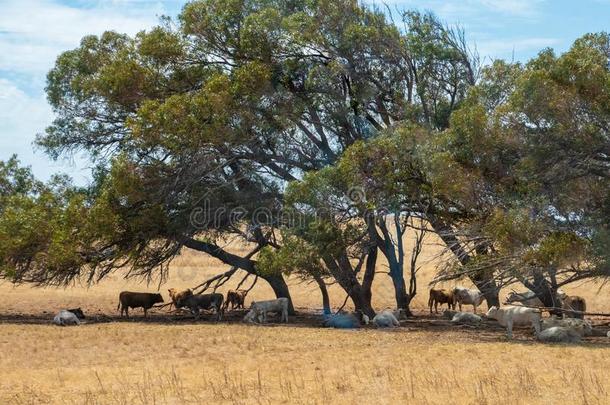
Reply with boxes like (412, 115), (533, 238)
(0, 0), (177, 182)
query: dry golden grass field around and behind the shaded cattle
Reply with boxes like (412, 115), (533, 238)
(0, 230), (610, 405)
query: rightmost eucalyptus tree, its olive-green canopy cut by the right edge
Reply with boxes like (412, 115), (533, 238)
(430, 33), (610, 306)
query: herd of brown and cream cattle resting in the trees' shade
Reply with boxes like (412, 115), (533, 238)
(53, 287), (610, 343)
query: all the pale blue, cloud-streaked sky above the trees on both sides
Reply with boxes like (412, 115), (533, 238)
(0, 0), (610, 184)
